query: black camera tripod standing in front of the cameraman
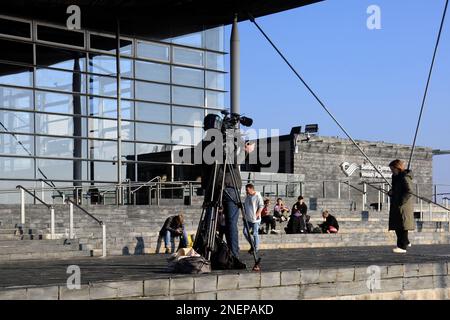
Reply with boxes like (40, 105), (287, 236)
(194, 140), (261, 271)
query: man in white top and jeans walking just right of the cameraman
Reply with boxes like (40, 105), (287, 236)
(244, 183), (264, 253)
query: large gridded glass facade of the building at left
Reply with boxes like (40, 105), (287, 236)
(0, 18), (226, 189)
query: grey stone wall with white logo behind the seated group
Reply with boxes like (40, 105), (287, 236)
(293, 136), (433, 203)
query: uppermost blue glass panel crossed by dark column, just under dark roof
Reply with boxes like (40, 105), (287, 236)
(36, 69), (86, 92)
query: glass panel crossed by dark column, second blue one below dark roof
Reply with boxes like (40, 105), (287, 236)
(36, 91), (86, 115)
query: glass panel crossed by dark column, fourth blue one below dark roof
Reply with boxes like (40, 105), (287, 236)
(36, 137), (87, 158)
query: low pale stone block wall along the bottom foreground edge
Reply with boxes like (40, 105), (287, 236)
(0, 262), (450, 300)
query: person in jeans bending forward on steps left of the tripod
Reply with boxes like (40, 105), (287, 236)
(156, 214), (188, 253)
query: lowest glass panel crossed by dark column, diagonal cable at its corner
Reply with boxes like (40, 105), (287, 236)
(36, 159), (87, 180)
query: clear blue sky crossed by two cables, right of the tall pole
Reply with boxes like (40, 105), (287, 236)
(226, 0), (450, 190)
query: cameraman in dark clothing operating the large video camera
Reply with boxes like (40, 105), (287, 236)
(201, 114), (255, 258)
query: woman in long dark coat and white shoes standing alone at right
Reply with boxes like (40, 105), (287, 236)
(388, 159), (415, 253)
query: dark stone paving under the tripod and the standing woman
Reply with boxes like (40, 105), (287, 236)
(0, 245), (450, 295)
